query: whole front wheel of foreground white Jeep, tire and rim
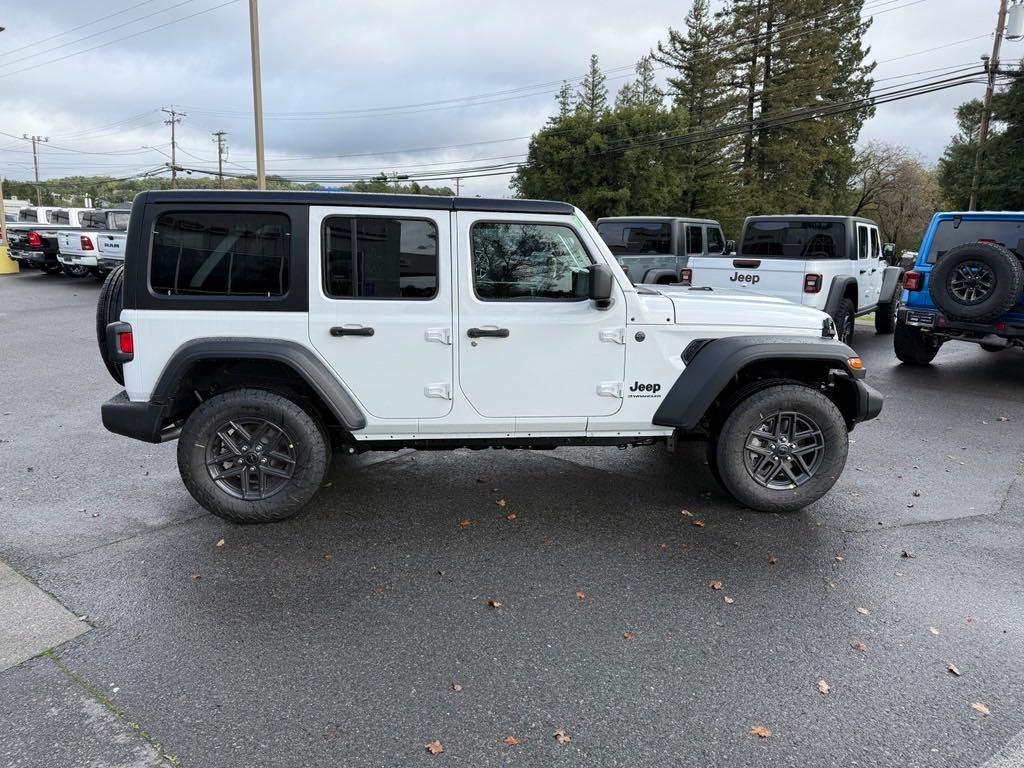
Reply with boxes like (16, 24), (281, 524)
(717, 384), (849, 512)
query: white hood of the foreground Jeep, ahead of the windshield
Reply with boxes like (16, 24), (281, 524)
(644, 286), (828, 333)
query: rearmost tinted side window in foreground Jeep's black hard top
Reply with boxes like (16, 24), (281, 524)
(150, 212), (292, 298)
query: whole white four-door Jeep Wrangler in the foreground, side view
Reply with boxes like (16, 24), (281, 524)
(97, 191), (882, 522)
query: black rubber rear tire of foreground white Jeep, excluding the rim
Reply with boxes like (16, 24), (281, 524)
(178, 389), (331, 523)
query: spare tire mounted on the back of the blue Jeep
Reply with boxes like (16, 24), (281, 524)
(928, 243), (1024, 323)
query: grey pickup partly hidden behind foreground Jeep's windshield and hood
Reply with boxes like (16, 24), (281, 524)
(596, 216), (735, 285)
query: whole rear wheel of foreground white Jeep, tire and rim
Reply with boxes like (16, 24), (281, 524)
(178, 389), (330, 523)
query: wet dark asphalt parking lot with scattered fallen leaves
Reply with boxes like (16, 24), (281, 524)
(0, 272), (1024, 768)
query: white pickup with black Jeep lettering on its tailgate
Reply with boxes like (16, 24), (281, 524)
(681, 215), (903, 343)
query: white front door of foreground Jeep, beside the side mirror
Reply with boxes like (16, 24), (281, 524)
(456, 211), (626, 421)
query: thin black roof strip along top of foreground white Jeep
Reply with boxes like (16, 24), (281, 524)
(135, 189), (574, 215)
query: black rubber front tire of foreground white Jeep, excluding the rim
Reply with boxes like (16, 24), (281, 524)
(717, 384), (850, 512)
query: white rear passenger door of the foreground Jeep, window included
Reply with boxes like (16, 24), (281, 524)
(309, 206), (454, 420)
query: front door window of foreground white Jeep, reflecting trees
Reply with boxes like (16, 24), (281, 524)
(470, 221), (591, 301)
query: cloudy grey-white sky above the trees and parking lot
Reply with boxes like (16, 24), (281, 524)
(0, 0), (1003, 195)
